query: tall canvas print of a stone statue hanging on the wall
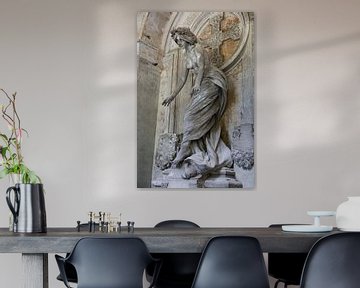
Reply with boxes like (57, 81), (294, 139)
(137, 11), (256, 189)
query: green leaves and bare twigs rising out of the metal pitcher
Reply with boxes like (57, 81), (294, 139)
(0, 88), (41, 184)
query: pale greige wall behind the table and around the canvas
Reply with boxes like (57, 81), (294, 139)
(0, 0), (360, 287)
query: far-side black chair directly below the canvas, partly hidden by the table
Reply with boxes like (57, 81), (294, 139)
(146, 220), (201, 288)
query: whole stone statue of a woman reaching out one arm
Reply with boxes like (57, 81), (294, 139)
(162, 27), (233, 179)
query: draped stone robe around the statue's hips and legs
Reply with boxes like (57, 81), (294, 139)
(183, 67), (232, 174)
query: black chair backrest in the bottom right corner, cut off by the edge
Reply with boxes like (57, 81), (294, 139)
(300, 232), (360, 288)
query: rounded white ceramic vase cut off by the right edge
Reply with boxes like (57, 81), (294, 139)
(336, 196), (360, 231)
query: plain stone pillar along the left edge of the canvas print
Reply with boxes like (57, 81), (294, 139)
(138, 12), (171, 188)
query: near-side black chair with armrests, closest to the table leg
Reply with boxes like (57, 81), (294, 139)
(55, 237), (160, 288)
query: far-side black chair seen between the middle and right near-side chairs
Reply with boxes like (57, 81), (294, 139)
(268, 224), (307, 288)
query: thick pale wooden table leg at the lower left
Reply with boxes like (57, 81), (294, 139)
(22, 253), (49, 288)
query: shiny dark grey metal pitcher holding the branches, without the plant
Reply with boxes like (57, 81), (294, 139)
(6, 184), (47, 233)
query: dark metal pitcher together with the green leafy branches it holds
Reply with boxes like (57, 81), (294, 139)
(0, 88), (47, 233)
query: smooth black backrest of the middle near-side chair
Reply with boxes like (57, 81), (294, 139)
(192, 236), (269, 288)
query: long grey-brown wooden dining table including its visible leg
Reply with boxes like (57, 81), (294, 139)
(0, 227), (338, 288)
